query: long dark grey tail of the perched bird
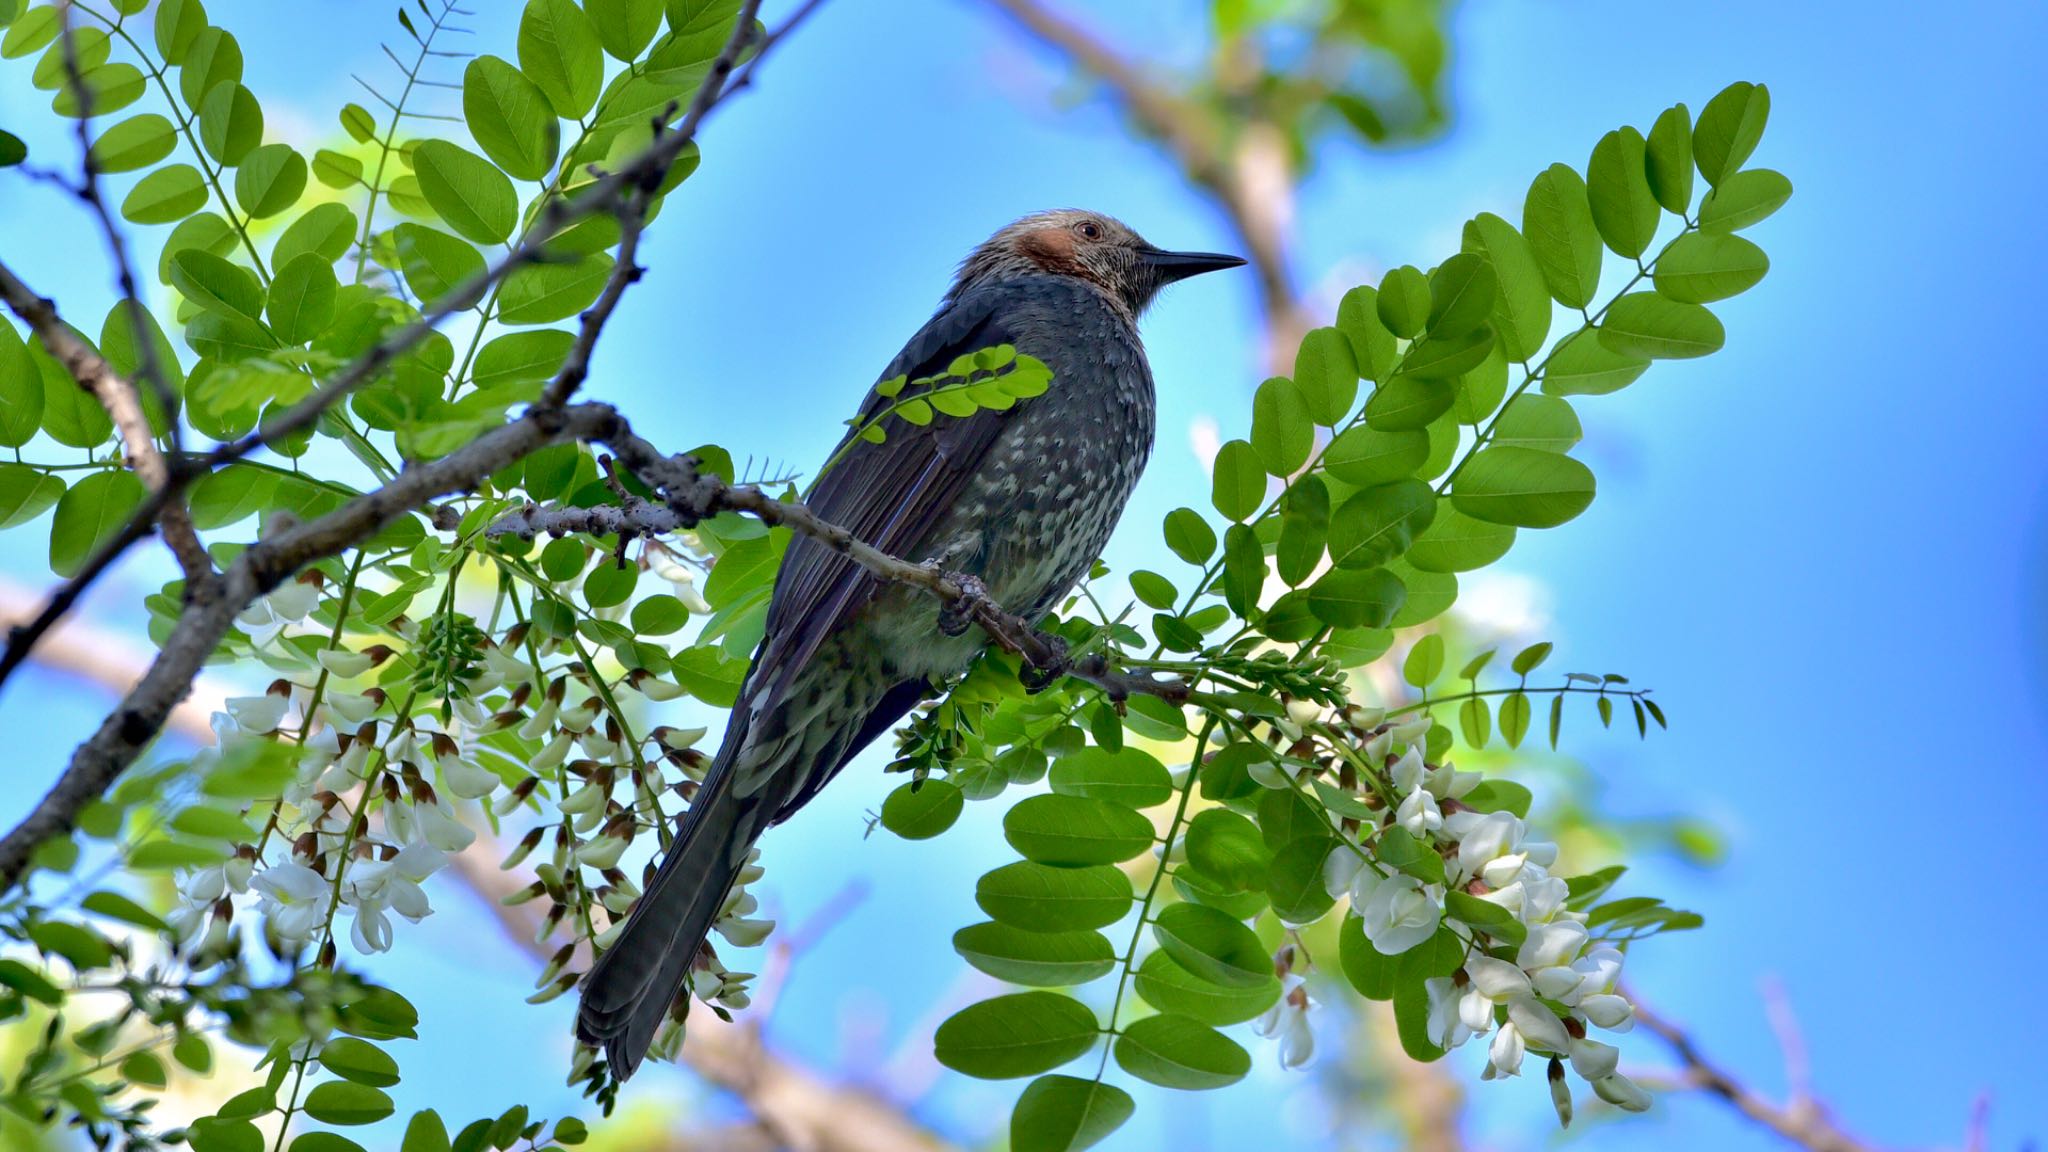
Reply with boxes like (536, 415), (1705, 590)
(575, 756), (764, 1080)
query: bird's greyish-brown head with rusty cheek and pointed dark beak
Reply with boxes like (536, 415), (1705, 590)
(950, 209), (1243, 318)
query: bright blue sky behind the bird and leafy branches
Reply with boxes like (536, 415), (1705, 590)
(0, 0), (2048, 1150)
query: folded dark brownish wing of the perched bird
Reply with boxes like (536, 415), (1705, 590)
(748, 280), (1032, 725)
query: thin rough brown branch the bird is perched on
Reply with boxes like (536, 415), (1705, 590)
(485, 453), (1190, 703)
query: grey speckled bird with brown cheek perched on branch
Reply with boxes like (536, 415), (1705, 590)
(575, 209), (1245, 1080)
